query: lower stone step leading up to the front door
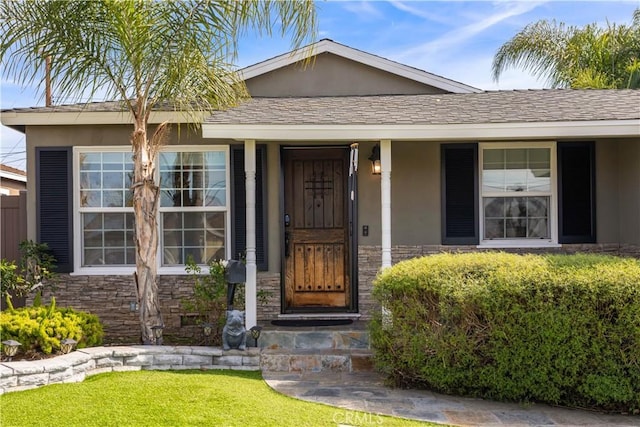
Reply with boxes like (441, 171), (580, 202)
(260, 348), (373, 373)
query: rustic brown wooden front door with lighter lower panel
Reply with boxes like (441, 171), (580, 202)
(283, 147), (351, 312)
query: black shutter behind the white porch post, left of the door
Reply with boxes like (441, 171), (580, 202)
(231, 146), (268, 271)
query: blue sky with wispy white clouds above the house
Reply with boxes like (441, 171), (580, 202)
(0, 0), (640, 169)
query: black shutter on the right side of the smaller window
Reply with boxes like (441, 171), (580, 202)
(558, 142), (596, 243)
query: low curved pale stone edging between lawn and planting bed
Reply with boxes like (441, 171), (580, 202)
(0, 345), (260, 394)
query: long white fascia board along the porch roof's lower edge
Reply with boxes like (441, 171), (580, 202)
(202, 119), (640, 141)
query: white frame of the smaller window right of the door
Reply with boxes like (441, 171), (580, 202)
(478, 141), (560, 248)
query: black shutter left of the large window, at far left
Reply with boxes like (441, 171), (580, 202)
(36, 147), (73, 273)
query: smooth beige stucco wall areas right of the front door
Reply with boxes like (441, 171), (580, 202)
(358, 139), (640, 245)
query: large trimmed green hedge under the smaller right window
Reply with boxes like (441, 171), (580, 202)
(371, 252), (640, 412)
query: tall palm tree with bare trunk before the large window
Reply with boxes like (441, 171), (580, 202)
(0, 0), (317, 343)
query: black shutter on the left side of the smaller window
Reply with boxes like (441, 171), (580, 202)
(441, 144), (478, 245)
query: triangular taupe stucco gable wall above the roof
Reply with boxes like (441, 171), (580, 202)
(246, 53), (445, 97)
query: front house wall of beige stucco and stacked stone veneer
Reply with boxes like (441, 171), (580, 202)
(20, 126), (640, 342)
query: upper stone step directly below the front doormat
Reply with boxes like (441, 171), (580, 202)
(258, 329), (370, 350)
